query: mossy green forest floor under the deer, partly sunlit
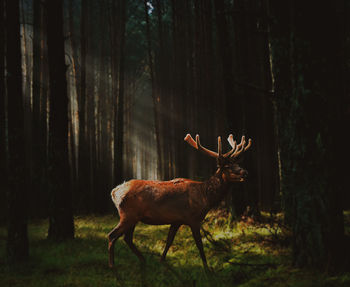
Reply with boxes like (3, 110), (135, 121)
(0, 212), (350, 287)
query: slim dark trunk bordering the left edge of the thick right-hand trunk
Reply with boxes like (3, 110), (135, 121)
(258, 0), (281, 212)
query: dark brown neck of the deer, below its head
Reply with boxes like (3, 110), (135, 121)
(204, 170), (230, 210)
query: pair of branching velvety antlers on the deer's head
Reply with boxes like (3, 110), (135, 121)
(184, 134), (252, 159)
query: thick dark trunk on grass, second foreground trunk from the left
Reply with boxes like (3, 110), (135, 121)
(47, 0), (74, 240)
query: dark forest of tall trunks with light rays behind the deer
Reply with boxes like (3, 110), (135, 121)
(0, 0), (350, 276)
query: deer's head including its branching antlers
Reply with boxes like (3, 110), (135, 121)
(185, 134), (252, 182)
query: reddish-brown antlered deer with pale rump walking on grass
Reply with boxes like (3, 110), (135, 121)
(108, 134), (252, 271)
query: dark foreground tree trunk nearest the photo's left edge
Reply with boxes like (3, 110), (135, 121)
(6, 1), (29, 262)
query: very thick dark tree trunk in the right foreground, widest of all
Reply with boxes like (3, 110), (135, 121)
(271, 0), (349, 271)
